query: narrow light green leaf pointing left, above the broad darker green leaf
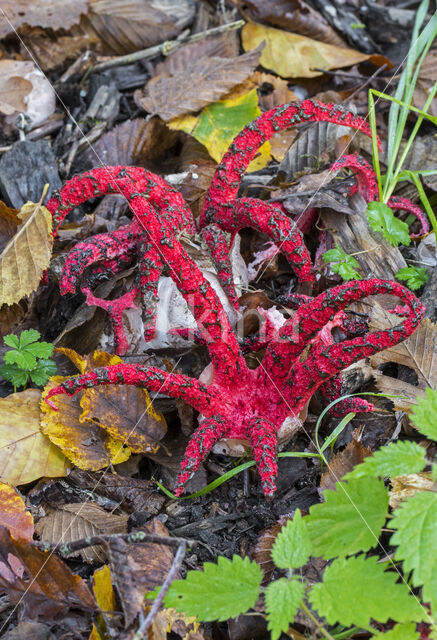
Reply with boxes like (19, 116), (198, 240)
(343, 440), (427, 480)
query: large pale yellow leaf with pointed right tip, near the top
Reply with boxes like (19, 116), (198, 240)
(241, 22), (369, 78)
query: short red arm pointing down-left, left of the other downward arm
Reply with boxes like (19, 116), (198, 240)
(175, 415), (227, 496)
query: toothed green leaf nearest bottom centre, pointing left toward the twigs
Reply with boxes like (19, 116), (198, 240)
(164, 555), (262, 622)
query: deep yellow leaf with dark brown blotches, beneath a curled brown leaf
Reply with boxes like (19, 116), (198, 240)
(41, 376), (131, 471)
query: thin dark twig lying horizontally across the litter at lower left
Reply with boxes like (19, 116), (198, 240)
(34, 531), (196, 557)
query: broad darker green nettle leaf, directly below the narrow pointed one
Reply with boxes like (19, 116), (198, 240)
(305, 478), (388, 560)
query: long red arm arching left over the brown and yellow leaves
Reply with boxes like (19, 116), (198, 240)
(45, 363), (222, 415)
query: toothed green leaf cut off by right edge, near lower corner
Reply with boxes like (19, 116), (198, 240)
(390, 491), (437, 611)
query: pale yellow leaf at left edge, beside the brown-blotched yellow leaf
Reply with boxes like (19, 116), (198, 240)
(0, 389), (68, 485)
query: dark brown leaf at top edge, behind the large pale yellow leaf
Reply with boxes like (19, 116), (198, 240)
(232, 0), (347, 47)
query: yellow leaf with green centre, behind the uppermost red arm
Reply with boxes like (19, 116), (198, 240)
(169, 87), (270, 172)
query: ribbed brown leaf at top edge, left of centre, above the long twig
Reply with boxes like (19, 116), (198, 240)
(81, 0), (195, 54)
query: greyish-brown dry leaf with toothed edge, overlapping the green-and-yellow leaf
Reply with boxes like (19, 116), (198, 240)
(134, 49), (260, 122)
